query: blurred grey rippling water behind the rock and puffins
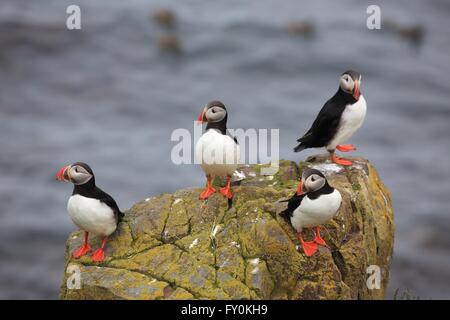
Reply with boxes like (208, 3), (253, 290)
(0, 0), (450, 299)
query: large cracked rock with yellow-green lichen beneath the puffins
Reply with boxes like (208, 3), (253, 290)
(61, 156), (395, 299)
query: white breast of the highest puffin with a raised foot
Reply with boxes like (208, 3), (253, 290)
(326, 95), (367, 150)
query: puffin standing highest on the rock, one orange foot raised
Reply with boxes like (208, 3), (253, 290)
(294, 70), (367, 166)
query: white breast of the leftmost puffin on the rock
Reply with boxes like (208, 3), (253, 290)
(67, 194), (117, 236)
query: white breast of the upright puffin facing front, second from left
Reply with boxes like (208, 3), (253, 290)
(195, 129), (240, 176)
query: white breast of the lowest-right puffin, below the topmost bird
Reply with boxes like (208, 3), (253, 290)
(291, 189), (342, 232)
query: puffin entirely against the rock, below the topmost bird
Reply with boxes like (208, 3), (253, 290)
(279, 169), (342, 257)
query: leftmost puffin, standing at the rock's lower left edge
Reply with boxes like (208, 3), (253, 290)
(56, 162), (124, 262)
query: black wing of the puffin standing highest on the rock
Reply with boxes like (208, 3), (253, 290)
(294, 95), (346, 152)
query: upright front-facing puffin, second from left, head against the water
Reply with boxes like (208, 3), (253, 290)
(195, 100), (240, 200)
